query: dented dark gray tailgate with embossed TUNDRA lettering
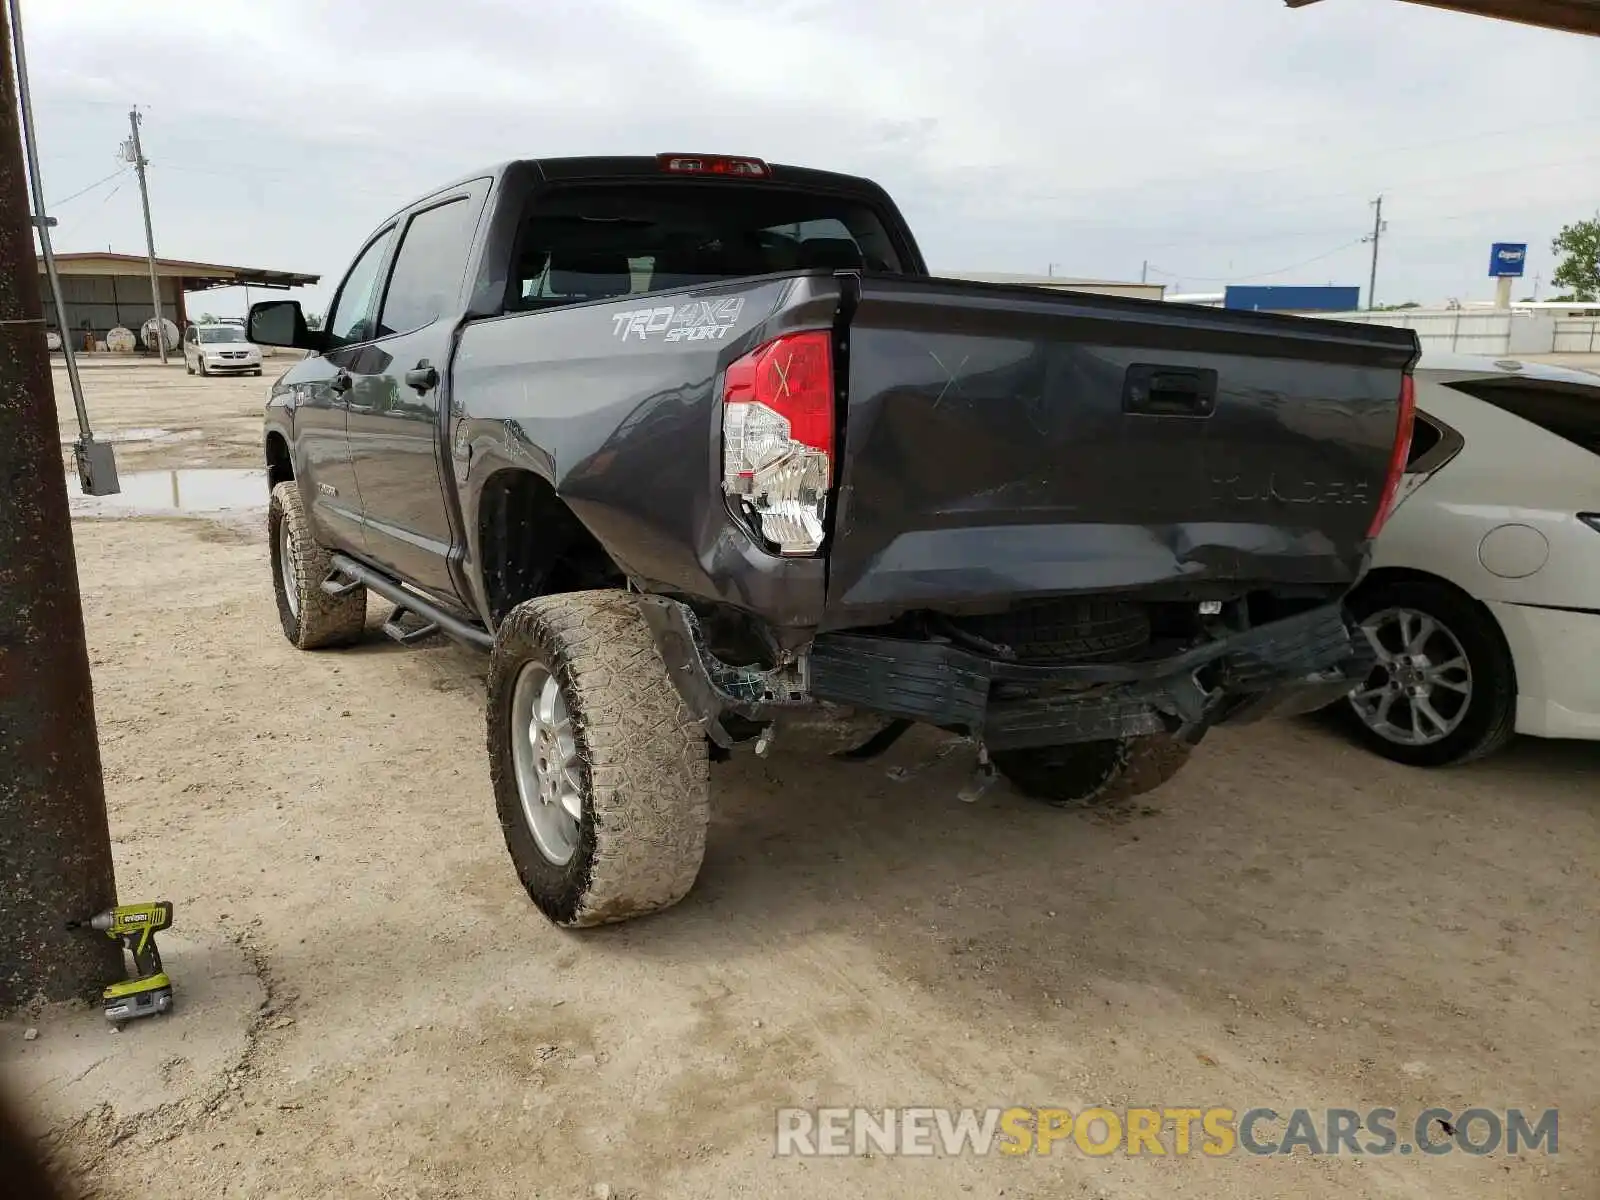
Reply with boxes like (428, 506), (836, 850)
(826, 277), (1418, 627)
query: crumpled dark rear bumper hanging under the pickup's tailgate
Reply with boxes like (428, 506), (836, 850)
(637, 595), (1373, 749)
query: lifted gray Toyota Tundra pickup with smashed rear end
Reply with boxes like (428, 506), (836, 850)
(250, 155), (1418, 925)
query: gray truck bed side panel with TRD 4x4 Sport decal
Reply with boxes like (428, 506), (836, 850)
(451, 277), (838, 630)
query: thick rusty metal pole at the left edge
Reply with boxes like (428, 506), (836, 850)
(0, 5), (123, 1011)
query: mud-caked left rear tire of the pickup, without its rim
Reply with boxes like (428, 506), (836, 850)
(488, 590), (710, 926)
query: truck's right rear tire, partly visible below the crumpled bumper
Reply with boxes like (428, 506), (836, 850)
(992, 734), (1194, 808)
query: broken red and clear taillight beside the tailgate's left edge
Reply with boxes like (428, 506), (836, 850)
(722, 330), (834, 554)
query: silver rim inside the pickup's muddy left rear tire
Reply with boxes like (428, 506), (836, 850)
(510, 662), (584, 867)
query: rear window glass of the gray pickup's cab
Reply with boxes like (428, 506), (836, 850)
(507, 181), (904, 309)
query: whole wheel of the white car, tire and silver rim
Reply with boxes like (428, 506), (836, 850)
(1344, 579), (1517, 766)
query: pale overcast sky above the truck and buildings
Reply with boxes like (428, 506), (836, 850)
(22, 0), (1600, 315)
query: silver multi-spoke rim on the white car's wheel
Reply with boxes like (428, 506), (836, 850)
(1350, 608), (1472, 746)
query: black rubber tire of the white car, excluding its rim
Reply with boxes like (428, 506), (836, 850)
(1334, 579), (1517, 766)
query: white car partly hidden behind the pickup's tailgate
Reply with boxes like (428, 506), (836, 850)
(1344, 355), (1600, 766)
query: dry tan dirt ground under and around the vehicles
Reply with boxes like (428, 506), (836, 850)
(0, 368), (1600, 1200)
